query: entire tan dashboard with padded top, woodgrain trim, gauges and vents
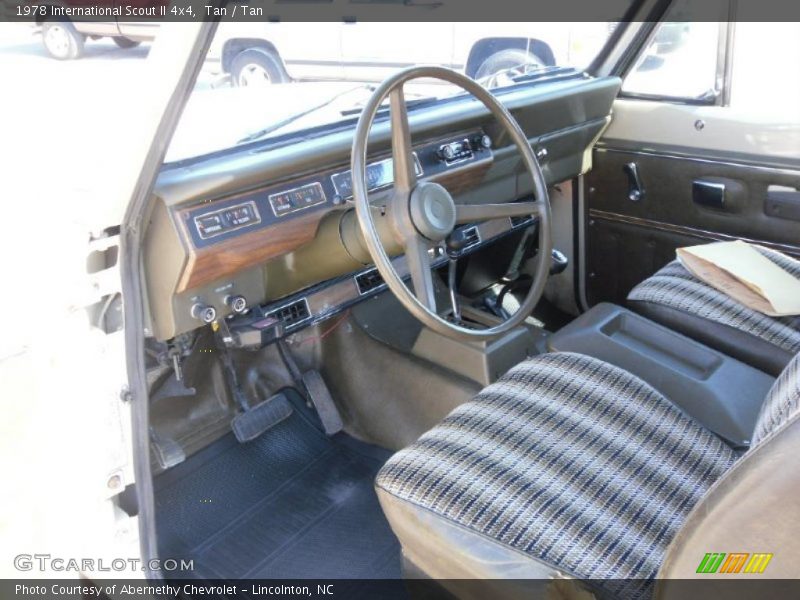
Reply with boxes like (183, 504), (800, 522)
(144, 74), (619, 340)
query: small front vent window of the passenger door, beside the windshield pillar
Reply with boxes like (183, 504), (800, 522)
(622, 22), (725, 104)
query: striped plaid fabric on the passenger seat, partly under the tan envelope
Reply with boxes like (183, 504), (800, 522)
(628, 246), (800, 360)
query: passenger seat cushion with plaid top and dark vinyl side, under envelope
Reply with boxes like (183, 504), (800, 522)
(628, 246), (800, 376)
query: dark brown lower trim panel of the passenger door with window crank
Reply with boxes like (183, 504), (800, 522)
(585, 146), (800, 306)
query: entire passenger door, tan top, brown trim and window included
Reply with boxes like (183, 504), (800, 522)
(579, 17), (800, 306)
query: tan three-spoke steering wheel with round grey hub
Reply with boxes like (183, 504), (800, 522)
(351, 67), (552, 340)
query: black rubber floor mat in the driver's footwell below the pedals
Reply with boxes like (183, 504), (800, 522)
(155, 390), (401, 579)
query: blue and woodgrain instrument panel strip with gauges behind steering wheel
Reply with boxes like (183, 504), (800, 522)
(170, 131), (492, 292)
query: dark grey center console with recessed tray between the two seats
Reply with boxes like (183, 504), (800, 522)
(548, 304), (774, 448)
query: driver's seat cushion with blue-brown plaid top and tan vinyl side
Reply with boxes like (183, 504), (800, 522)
(376, 353), (736, 597)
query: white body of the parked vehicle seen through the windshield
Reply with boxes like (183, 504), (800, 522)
(209, 22), (608, 85)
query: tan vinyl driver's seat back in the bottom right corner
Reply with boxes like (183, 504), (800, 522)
(655, 355), (800, 584)
